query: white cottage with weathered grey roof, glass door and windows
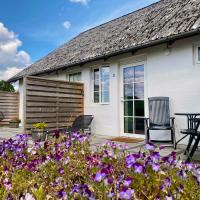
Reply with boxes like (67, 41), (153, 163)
(9, 0), (200, 144)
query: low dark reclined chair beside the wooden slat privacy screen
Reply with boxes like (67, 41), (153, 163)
(68, 115), (94, 134)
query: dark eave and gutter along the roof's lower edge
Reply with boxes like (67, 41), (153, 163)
(8, 28), (200, 82)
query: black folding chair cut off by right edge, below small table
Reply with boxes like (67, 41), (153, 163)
(181, 118), (200, 161)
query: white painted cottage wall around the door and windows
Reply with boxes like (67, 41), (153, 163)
(19, 36), (200, 144)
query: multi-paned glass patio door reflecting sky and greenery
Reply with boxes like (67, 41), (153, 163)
(121, 64), (144, 138)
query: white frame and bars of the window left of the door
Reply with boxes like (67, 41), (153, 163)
(92, 65), (110, 105)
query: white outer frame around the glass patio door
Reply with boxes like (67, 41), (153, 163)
(119, 61), (146, 139)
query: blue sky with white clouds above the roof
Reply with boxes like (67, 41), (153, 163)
(0, 0), (158, 80)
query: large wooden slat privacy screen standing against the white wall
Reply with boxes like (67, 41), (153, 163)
(24, 76), (84, 132)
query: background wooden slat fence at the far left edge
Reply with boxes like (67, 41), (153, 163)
(0, 91), (19, 126)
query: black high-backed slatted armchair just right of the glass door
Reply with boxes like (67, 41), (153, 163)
(145, 97), (176, 149)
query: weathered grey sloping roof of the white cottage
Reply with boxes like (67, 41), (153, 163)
(9, 0), (200, 81)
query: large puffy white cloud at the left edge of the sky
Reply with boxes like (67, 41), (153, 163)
(0, 22), (31, 80)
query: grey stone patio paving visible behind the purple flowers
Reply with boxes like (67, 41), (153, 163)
(0, 127), (200, 162)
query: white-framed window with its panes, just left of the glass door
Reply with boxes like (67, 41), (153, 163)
(93, 66), (110, 103)
